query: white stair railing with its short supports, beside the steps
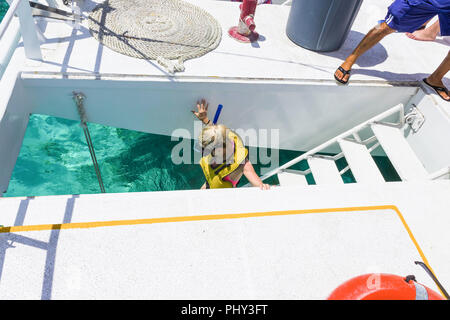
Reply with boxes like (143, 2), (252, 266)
(244, 103), (404, 187)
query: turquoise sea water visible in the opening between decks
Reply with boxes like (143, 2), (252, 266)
(4, 114), (398, 197)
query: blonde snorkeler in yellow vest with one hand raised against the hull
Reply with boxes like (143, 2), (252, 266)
(192, 99), (270, 190)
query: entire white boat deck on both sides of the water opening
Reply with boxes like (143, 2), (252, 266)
(0, 0), (450, 299)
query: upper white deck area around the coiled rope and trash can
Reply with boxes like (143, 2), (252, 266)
(10, 0), (450, 89)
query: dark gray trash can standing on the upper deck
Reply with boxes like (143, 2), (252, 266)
(286, 0), (362, 51)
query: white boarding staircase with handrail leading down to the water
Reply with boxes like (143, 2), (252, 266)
(250, 104), (450, 186)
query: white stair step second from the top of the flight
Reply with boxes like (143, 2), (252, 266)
(338, 140), (385, 183)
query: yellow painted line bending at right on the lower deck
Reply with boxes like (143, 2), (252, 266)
(0, 205), (443, 295)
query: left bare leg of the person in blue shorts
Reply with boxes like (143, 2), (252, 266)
(335, 22), (395, 81)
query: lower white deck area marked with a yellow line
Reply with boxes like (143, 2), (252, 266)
(0, 180), (450, 299)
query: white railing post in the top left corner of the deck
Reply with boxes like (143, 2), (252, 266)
(0, 0), (42, 64)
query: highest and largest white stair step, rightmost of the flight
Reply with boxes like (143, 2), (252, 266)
(371, 124), (428, 181)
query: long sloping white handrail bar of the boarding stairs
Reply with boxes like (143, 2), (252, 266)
(244, 103), (404, 187)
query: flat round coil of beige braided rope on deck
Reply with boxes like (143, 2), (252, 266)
(89, 0), (222, 73)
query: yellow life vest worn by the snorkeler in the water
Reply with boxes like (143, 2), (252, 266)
(200, 130), (248, 189)
